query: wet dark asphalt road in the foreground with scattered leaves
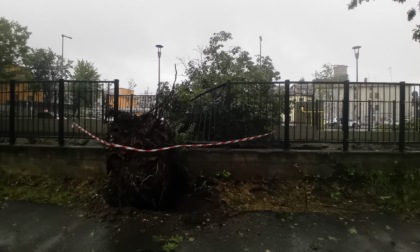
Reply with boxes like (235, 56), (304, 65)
(0, 202), (420, 252)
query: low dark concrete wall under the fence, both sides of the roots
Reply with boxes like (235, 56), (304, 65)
(0, 145), (420, 179)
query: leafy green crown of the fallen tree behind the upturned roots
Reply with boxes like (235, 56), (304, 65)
(157, 31), (284, 141)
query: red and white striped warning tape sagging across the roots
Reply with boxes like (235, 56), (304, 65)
(71, 123), (274, 152)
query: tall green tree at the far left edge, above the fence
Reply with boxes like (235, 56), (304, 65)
(0, 17), (31, 81)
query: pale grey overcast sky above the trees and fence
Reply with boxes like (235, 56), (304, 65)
(0, 0), (420, 94)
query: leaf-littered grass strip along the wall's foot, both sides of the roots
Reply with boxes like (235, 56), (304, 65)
(0, 163), (420, 220)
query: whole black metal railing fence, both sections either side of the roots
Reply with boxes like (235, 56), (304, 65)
(0, 80), (420, 151)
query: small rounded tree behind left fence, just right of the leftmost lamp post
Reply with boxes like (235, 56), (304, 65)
(70, 59), (101, 117)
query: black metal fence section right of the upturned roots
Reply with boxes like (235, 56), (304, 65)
(192, 80), (420, 151)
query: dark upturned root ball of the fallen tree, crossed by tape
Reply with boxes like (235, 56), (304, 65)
(105, 109), (188, 210)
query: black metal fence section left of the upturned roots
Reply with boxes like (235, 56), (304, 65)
(0, 80), (155, 146)
